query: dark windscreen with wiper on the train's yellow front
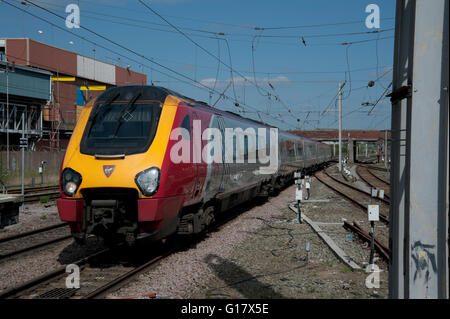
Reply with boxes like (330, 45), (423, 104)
(80, 96), (162, 155)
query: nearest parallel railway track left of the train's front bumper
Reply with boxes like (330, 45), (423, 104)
(0, 223), (71, 261)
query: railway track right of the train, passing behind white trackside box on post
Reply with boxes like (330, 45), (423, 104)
(315, 171), (389, 224)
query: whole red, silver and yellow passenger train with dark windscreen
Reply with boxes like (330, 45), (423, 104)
(57, 86), (331, 243)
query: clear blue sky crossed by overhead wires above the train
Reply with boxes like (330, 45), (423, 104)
(0, 0), (395, 129)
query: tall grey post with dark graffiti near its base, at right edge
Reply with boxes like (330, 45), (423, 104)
(389, 0), (449, 298)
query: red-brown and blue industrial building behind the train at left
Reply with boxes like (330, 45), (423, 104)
(0, 38), (147, 151)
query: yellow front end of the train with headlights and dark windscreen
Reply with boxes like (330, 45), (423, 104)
(57, 86), (180, 243)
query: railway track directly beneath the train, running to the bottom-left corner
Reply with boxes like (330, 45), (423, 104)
(0, 195), (268, 299)
